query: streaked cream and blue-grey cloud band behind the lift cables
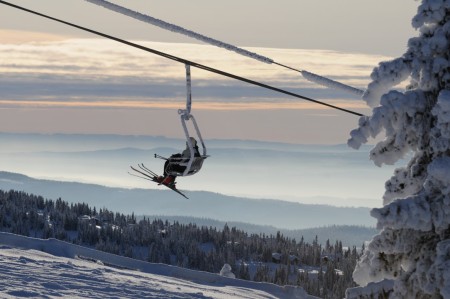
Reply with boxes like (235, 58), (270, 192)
(0, 38), (387, 109)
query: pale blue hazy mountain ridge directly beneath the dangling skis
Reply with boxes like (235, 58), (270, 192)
(0, 172), (375, 230)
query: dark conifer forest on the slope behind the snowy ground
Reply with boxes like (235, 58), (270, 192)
(0, 190), (364, 298)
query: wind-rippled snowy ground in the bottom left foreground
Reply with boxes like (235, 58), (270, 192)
(0, 233), (314, 299)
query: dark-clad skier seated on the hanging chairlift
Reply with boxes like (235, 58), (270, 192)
(157, 137), (201, 186)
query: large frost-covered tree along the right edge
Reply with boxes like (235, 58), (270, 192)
(347, 0), (450, 298)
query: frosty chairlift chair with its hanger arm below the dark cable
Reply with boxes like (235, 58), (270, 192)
(155, 64), (209, 176)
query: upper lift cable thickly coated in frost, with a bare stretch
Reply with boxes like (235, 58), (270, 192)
(85, 0), (364, 96)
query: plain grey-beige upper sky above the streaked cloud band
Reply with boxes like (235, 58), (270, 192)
(1, 0), (418, 55)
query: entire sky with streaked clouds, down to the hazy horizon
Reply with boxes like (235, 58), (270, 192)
(0, 0), (418, 144)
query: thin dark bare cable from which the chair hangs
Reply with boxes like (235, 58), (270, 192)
(0, 0), (364, 116)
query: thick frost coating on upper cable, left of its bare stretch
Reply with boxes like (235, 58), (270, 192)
(85, 0), (273, 64)
